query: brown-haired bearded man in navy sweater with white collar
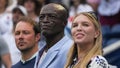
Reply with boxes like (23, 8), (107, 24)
(12, 17), (40, 68)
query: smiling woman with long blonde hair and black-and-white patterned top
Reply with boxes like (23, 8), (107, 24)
(65, 12), (108, 68)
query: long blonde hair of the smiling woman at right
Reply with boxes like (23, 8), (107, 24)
(65, 12), (102, 68)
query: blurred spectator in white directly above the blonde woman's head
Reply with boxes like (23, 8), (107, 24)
(69, 0), (93, 22)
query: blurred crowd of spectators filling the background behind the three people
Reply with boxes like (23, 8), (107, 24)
(0, 0), (120, 65)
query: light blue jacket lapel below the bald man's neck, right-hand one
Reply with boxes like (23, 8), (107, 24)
(40, 37), (67, 68)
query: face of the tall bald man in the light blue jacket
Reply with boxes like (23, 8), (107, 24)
(39, 5), (64, 36)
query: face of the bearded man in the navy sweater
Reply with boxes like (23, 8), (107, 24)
(15, 21), (38, 51)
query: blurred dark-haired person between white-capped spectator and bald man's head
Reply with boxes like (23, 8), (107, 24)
(22, 0), (42, 23)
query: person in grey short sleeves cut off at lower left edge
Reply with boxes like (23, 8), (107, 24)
(0, 35), (11, 68)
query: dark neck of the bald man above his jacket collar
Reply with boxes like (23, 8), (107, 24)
(45, 32), (64, 51)
